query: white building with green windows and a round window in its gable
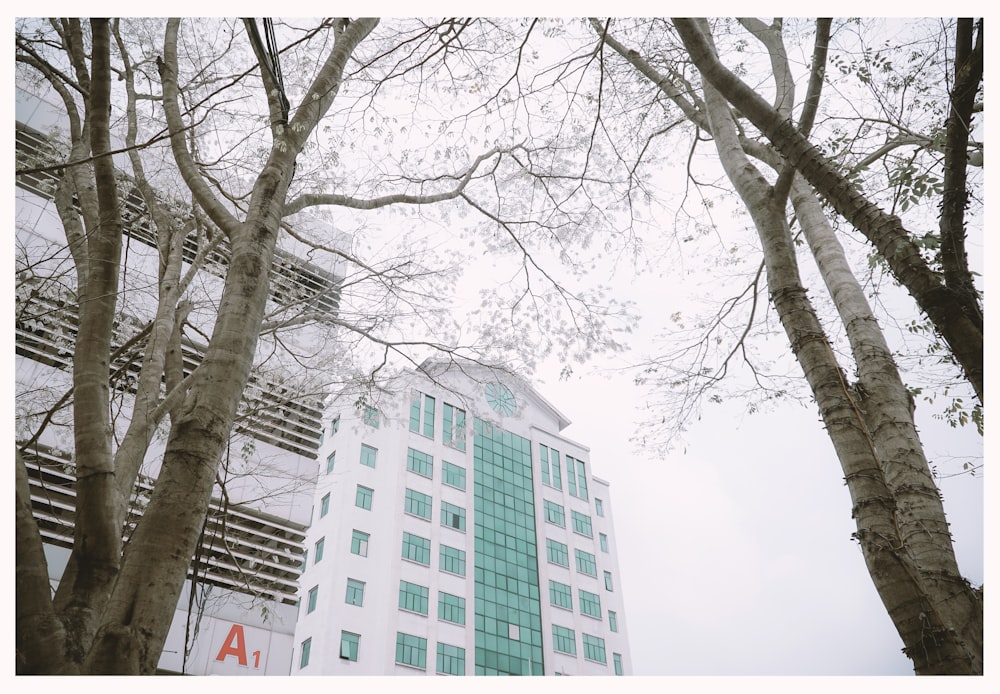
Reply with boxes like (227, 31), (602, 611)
(292, 360), (631, 675)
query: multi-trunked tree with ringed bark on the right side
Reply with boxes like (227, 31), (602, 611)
(590, 19), (983, 674)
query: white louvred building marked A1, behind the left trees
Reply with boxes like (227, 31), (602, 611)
(15, 88), (340, 675)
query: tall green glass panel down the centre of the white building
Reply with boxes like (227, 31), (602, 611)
(474, 418), (544, 675)
